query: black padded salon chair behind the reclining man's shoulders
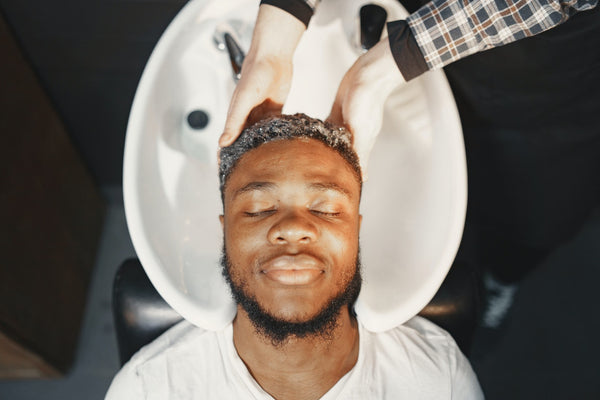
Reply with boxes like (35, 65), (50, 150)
(112, 258), (480, 365)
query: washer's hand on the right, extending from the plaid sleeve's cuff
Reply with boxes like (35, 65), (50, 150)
(327, 37), (405, 178)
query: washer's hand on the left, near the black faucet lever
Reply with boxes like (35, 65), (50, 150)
(219, 4), (306, 147)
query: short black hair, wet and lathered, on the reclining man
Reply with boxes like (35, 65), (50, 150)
(219, 114), (362, 199)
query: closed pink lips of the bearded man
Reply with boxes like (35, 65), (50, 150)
(261, 254), (324, 286)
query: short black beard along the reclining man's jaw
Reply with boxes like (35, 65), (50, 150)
(221, 245), (362, 347)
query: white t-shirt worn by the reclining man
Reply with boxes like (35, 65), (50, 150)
(106, 317), (483, 400)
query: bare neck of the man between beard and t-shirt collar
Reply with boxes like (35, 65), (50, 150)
(233, 307), (359, 400)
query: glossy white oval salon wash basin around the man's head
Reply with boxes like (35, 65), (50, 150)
(123, 0), (466, 331)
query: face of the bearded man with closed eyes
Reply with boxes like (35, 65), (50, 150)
(221, 139), (360, 338)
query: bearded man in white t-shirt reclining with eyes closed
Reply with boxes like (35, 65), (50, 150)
(107, 114), (483, 400)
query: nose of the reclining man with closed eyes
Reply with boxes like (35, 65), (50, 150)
(268, 211), (318, 244)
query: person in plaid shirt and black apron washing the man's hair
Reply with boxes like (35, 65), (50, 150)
(220, 0), (600, 330)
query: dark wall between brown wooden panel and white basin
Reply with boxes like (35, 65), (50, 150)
(0, 0), (187, 186)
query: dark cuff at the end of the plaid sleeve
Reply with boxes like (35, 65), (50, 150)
(387, 20), (429, 81)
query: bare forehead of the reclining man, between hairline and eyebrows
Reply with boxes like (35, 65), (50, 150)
(225, 138), (360, 198)
